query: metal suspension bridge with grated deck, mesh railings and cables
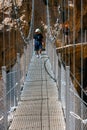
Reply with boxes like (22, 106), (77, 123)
(0, 0), (87, 130)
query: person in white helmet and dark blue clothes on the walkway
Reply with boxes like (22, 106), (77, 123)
(33, 28), (43, 58)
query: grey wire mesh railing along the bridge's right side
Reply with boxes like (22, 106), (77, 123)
(47, 41), (87, 130)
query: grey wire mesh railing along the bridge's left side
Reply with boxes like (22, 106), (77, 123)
(0, 41), (33, 130)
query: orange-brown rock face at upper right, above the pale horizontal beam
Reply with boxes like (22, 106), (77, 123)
(59, 0), (87, 42)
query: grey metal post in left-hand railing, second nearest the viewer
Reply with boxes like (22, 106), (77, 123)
(17, 53), (21, 101)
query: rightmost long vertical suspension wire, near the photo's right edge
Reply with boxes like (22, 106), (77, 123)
(81, 0), (83, 130)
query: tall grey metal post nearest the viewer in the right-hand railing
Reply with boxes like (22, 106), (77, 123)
(66, 66), (70, 130)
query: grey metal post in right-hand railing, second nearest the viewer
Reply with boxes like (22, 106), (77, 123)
(58, 53), (61, 101)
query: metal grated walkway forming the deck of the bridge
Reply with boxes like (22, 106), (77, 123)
(9, 52), (65, 130)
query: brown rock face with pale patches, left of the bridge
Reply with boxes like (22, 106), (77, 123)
(0, 0), (31, 72)
